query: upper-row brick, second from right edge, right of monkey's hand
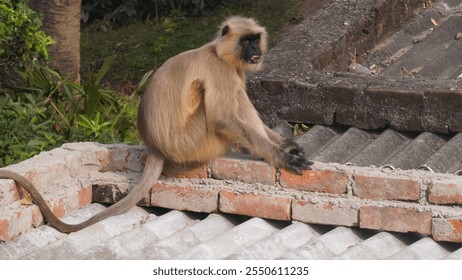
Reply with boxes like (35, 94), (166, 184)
(353, 173), (420, 201)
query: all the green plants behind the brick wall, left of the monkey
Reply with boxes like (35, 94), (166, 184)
(0, 0), (138, 166)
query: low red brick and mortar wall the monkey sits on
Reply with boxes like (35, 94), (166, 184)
(0, 143), (462, 242)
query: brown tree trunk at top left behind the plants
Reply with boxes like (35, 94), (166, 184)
(29, 0), (82, 82)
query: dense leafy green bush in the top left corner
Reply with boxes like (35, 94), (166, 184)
(0, 0), (54, 74)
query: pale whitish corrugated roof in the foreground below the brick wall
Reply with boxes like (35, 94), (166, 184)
(0, 204), (462, 260)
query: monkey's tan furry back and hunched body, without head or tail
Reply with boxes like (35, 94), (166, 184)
(138, 42), (242, 162)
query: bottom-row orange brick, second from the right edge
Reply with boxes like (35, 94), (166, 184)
(359, 206), (432, 234)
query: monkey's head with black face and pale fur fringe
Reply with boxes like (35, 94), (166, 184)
(216, 16), (267, 71)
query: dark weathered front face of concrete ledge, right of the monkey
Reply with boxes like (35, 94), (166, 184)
(250, 73), (462, 133)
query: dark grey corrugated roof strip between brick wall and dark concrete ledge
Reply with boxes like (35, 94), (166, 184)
(288, 125), (462, 174)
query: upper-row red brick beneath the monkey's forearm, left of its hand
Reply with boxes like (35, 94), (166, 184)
(210, 155), (276, 185)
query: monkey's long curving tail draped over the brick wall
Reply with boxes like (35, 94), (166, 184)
(0, 153), (164, 233)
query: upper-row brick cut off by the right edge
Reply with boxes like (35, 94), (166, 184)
(428, 180), (462, 204)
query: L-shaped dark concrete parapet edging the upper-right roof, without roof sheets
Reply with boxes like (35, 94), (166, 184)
(248, 0), (462, 133)
